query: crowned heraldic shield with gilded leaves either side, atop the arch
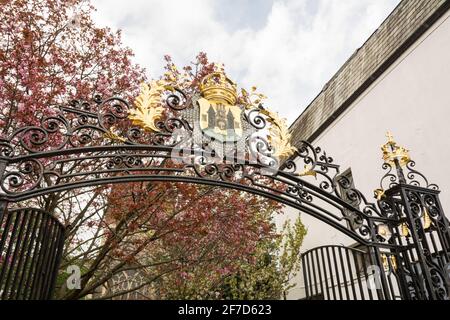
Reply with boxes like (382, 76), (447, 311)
(112, 64), (296, 165)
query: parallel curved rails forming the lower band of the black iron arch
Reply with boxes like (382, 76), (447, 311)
(0, 145), (392, 248)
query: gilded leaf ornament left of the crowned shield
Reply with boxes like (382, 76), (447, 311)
(128, 80), (168, 132)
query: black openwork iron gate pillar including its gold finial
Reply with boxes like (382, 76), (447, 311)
(378, 135), (450, 300)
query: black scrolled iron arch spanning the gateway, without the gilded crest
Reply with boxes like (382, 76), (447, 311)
(0, 90), (400, 248)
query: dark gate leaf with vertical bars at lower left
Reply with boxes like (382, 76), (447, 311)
(0, 209), (64, 300)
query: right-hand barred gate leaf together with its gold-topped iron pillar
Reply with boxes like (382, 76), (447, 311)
(302, 146), (450, 300)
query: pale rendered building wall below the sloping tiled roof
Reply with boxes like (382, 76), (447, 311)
(280, 13), (450, 299)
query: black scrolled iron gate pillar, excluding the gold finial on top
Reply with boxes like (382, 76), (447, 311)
(383, 184), (450, 300)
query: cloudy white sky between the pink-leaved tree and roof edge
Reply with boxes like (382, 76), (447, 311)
(92, 0), (400, 124)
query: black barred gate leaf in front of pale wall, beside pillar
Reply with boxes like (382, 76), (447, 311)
(302, 245), (401, 300)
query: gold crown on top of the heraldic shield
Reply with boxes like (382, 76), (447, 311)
(200, 64), (237, 105)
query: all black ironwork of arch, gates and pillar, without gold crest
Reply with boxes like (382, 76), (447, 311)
(0, 88), (450, 299)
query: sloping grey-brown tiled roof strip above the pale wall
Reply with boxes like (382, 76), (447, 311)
(290, 0), (450, 144)
